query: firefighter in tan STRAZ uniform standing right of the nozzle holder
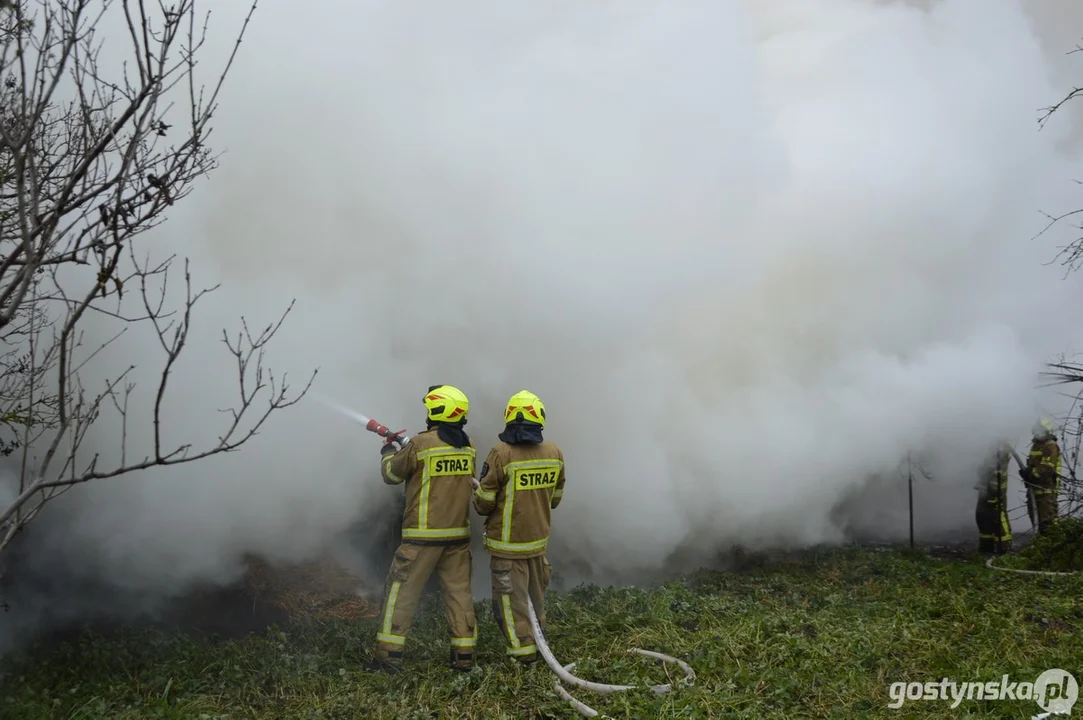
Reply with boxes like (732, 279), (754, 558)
(473, 390), (564, 663)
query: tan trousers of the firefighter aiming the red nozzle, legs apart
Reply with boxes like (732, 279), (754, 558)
(376, 541), (478, 667)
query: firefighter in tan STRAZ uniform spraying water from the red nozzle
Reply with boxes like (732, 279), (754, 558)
(368, 385), (478, 673)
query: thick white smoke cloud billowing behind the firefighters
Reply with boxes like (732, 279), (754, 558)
(6, 0), (1083, 627)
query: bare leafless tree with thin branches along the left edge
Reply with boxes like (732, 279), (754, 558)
(0, 0), (315, 552)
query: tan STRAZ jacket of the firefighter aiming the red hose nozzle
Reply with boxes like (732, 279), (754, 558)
(380, 429), (474, 545)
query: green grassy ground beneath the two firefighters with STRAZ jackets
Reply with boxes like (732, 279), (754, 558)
(0, 549), (1083, 720)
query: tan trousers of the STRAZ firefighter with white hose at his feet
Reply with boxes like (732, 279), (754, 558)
(490, 555), (552, 663)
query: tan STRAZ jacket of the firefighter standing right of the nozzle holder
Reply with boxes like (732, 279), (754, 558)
(473, 441), (564, 559)
